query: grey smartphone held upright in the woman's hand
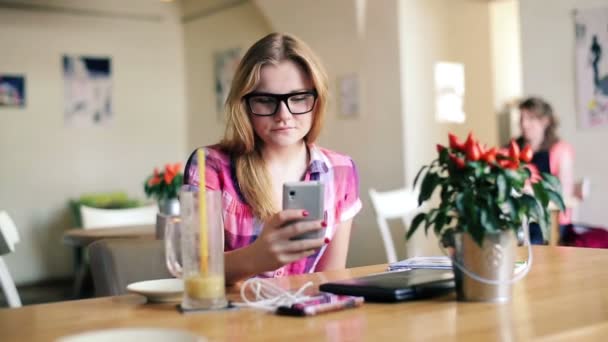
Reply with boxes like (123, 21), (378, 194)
(283, 181), (325, 240)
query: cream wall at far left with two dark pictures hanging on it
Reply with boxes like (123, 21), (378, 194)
(0, 0), (186, 283)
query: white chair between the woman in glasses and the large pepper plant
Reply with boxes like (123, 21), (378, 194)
(369, 188), (418, 263)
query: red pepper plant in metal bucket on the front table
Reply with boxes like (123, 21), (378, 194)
(406, 134), (564, 301)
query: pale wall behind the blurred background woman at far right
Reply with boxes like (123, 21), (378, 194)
(520, 0), (608, 226)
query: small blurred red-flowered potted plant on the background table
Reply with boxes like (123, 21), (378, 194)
(144, 163), (184, 215)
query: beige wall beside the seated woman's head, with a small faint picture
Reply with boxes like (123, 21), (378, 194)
(255, 0), (404, 266)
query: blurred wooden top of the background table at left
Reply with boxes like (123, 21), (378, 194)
(63, 225), (155, 247)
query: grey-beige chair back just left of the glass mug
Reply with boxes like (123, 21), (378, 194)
(88, 239), (173, 297)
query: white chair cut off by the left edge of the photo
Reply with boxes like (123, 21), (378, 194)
(0, 211), (21, 308)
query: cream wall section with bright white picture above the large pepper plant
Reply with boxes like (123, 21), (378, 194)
(399, 0), (498, 255)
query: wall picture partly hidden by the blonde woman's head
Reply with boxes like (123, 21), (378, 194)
(213, 48), (241, 117)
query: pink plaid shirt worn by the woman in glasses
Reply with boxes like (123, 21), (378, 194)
(185, 145), (361, 277)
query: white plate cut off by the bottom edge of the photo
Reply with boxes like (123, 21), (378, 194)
(57, 328), (207, 342)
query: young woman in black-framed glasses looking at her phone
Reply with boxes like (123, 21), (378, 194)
(185, 33), (361, 283)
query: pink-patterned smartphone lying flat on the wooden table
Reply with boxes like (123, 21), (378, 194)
(276, 293), (364, 316)
